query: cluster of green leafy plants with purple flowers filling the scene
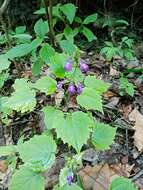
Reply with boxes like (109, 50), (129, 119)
(0, 3), (136, 190)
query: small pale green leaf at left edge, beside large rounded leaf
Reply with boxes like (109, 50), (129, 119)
(0, 145), (17, 156)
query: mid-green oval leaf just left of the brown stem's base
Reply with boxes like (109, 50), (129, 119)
(40, 44), (55, 64)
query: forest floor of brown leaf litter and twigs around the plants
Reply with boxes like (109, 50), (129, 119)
(0, 49), (143, 190)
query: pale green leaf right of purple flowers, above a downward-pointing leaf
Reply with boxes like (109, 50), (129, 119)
(84, 76), (111, 94)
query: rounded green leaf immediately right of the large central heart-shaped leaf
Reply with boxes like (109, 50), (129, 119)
(92, 122), (116, 150)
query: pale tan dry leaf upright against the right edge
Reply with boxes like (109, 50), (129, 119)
(129, 108), (143, 151)
